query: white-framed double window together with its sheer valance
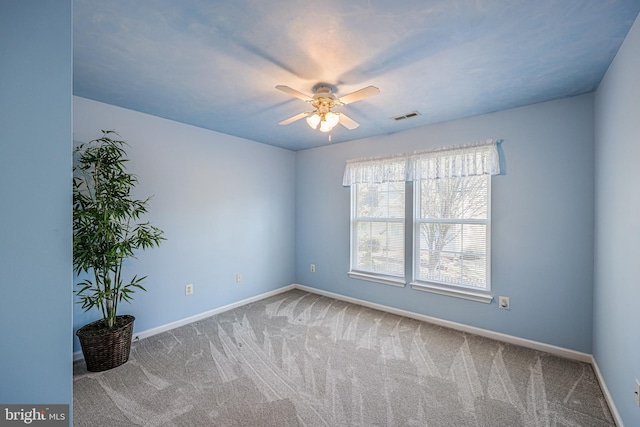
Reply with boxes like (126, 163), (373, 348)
(343, 140), (500, 303)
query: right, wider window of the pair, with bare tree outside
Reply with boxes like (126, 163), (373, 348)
(412, 175), (491, 301)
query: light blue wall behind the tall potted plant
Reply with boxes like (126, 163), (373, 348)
(74, 97), (295, 351)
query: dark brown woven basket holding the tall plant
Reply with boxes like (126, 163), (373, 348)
(76, 315), (135, 372)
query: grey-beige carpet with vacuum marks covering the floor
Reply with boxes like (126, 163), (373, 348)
(73, 290), (614, 427)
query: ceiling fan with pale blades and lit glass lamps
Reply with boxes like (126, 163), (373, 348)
(276, 84), (380, 132)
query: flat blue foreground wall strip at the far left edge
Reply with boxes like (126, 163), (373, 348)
(0, 0), (72, 404)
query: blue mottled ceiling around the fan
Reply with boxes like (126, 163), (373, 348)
(73, 0), (640, 150)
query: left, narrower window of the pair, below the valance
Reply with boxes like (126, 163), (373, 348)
(350, 181), (405, 285)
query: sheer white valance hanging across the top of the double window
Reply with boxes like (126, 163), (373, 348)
(342, 140), (500, 186)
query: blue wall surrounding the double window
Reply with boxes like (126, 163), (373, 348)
(296, 94), (594, 353)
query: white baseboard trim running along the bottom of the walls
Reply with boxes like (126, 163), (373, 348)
(73, 283), (623, 427)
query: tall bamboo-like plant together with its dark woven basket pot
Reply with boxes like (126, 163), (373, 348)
(73, 131), (164, 372)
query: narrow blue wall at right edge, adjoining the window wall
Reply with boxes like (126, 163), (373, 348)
(593, 13), (640, 426)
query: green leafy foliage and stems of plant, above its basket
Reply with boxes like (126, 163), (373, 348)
(72, 130), (165, 332)
